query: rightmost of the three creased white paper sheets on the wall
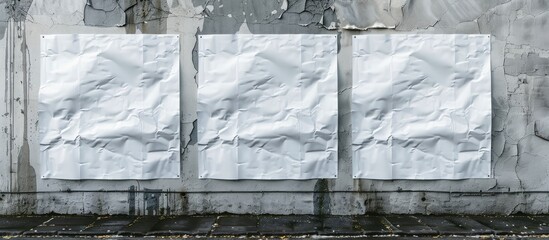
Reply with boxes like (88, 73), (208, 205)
(351, 35), (491, 179)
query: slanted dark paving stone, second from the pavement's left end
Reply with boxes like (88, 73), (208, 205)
(24, 216), (97, 235)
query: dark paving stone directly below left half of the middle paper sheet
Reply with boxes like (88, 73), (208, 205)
(212, 215), (259, 235)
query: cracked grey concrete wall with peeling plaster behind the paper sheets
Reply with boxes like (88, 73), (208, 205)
(0, 0), (549, 215)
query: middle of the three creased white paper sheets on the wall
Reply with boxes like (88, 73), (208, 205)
(198, 35), (337, 179)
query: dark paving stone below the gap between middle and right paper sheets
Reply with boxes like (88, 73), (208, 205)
(318, 216), (363, 235)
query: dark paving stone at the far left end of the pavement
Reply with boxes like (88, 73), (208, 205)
(0, 216), (51, 236)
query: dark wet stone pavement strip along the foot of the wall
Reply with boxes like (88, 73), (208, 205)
(0, 215), (549, 239)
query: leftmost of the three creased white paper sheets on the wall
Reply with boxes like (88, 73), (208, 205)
(39, 34), (180, 179)
